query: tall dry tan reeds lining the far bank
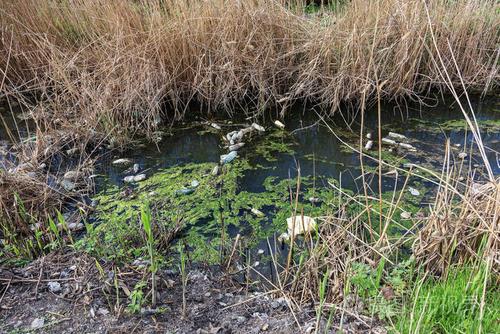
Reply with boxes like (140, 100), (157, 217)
(0, 0), (500, 139)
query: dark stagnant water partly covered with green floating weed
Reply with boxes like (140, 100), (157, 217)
(0, 97), (500, 271)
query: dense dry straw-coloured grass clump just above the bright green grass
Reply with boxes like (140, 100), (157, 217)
(413, 179), (500, 275)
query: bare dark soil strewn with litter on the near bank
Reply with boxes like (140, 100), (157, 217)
(0, 253), (385, 334)
